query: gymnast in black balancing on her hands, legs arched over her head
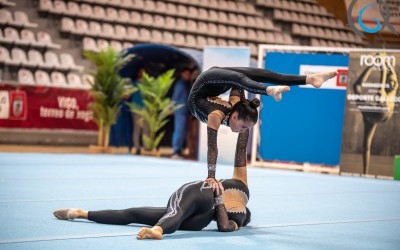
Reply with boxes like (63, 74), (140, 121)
(188, 67), (337, 189)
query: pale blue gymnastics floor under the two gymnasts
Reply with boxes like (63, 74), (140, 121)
(0, 153), (400, 250)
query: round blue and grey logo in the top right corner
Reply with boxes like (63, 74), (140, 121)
(347, 0), (397, 37)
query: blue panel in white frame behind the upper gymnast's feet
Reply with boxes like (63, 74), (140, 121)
(259, 52), (349, 166)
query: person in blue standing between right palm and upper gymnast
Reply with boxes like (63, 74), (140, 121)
(172, 67), (192, 159)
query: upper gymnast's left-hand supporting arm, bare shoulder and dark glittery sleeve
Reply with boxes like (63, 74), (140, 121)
(207, 110), (225, 179)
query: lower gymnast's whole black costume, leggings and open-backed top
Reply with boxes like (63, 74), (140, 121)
(88, 179), (249, 234)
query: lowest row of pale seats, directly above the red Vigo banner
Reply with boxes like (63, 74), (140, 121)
(18, 69), (93, 89)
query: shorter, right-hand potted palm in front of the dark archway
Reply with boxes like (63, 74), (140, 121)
(127, 70), (183, 156)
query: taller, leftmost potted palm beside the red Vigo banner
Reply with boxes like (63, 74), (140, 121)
(84, 47), (137, 153)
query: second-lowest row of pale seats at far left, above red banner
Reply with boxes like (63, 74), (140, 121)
(0, 46), (83, 71)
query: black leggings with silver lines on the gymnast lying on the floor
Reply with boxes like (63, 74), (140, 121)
(88, 181), (214, 234)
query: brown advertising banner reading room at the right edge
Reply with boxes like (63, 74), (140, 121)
(340, 52), (400, 176)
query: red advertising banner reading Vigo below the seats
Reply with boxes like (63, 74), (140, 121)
(0, 85), (97, 130)
